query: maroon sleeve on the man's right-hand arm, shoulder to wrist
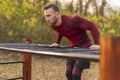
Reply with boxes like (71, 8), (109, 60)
(72, 16), (100, 44)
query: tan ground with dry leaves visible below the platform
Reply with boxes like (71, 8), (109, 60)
(0, 51), (99, 80)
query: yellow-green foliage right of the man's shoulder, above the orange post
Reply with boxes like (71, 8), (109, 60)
(86, 16), (120, 36)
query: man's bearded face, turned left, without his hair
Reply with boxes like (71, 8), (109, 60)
(44, 8), (58, 26)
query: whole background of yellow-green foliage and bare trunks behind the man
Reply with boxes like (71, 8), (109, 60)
(0, 0), (120, 44)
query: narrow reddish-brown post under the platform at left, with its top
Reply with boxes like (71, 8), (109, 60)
(22, 39), (32, 80)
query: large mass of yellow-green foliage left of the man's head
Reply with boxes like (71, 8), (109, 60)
(0, 0), (52, 42)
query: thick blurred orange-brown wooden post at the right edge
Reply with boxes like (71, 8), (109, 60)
(100, 37), (120, 80)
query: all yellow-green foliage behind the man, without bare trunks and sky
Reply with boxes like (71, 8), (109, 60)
(0, 0), (120, 44)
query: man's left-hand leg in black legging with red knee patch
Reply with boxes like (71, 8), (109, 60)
(66, 59), (75, 80)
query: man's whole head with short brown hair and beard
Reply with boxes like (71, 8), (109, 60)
(43, 3), (60, 26)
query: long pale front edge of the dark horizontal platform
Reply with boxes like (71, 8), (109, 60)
(0, 47), (100, 61)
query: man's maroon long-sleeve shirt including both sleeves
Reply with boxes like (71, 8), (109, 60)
(51, 15), (99, 47)
